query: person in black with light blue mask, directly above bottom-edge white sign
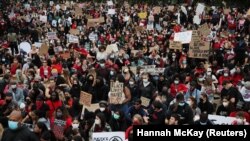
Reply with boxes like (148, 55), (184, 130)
(109, 110), (127, 131)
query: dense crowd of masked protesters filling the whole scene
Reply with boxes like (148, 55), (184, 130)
(0, 0), (250, 141)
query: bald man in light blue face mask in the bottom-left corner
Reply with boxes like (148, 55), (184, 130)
(1, 110), (39, 141)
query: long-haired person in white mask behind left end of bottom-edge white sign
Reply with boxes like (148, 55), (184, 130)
(89, 113), (112, 140)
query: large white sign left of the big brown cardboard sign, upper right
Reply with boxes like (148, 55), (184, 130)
(174, 31), (192, 44)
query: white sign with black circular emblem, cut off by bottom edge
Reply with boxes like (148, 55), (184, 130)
(92, 132), (125, 141)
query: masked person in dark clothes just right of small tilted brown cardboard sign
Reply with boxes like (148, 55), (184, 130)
(95, 100), (112, 121)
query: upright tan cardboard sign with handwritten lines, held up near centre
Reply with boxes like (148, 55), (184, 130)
(109, 81), (124, 104)
